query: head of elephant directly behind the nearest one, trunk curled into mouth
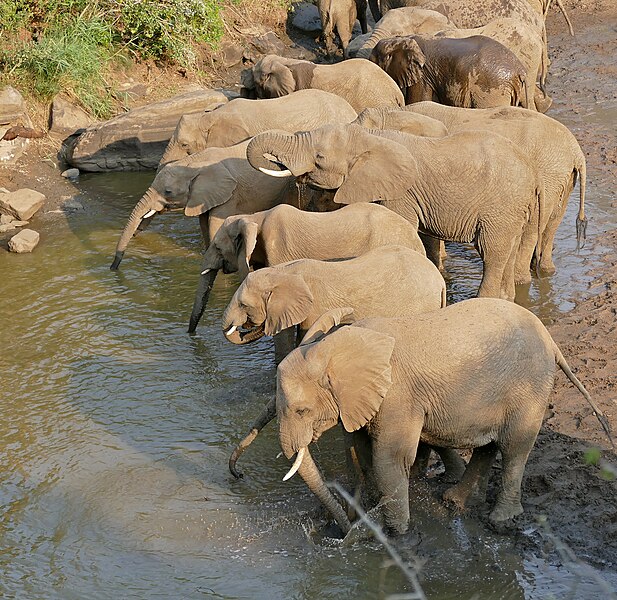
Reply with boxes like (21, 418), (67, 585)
(223, 267), (313, 344)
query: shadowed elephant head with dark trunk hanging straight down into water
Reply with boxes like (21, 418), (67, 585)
(189, 215), (260, 333)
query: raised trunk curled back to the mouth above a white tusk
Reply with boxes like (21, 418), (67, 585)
(246, 131), (313, 177)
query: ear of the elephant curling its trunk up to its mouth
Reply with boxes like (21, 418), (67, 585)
(334, 125), (418, 204)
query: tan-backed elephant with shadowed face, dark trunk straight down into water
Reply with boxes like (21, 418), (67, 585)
(189, 204), (425, 333)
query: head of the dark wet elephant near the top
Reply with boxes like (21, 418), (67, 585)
(370, 36), (426, 91)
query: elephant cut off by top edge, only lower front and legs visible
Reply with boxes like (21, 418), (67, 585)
(317, 0), (368, 57)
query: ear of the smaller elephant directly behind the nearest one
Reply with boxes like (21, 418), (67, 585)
(264, 274), (313, 335)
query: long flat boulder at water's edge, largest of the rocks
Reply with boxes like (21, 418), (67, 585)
(67, 88), (227, 172)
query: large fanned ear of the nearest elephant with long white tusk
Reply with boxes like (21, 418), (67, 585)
(306, 326), (394, 432)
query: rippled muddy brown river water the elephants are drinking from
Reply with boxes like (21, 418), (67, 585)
(0, 106), (617, 600)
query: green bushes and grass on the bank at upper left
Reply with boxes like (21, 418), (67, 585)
(0, 0), (235, 117)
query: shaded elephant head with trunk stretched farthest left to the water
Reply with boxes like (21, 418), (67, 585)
(111, 142), (248, 270)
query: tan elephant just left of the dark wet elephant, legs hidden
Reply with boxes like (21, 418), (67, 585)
(241, 54), (405, 112)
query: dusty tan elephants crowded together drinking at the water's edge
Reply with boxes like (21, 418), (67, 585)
(107, 0), (610, 533)
